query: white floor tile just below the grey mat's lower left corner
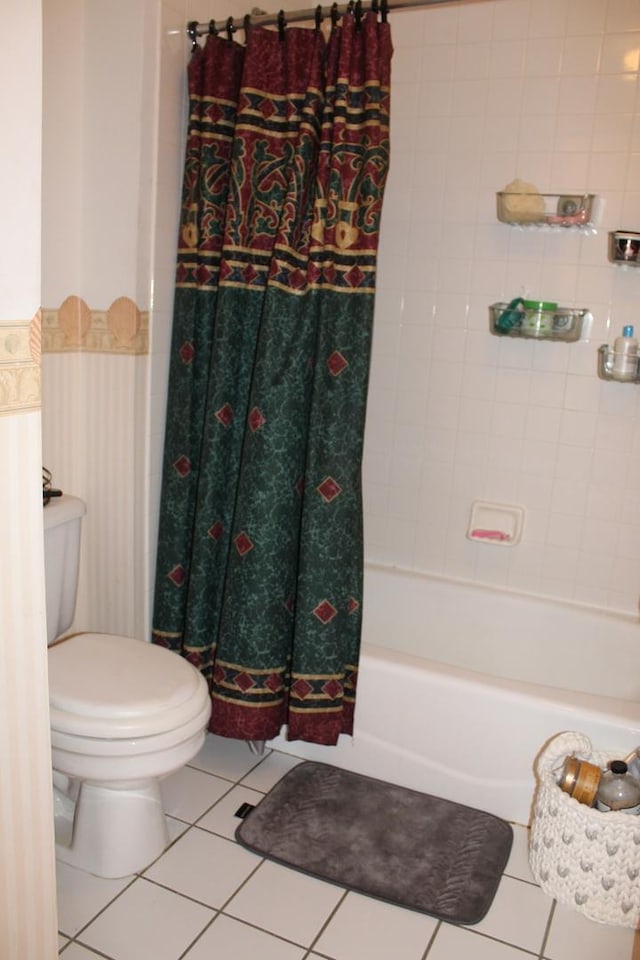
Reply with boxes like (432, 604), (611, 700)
(225, 861), (344, 946)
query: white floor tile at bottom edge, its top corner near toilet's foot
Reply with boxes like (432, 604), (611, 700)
(80, 878), (215, 960)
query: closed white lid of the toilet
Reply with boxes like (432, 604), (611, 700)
(48, 633), (209, 740)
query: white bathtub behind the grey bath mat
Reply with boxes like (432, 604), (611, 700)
(269, 564), (640, 824)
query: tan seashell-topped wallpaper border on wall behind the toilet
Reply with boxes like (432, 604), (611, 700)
(42, 295), (149, 355)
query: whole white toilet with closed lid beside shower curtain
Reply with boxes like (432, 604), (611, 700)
(44, 495), (211, 877)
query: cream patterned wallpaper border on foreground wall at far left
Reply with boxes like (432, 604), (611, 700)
(0, 310), (42, 416)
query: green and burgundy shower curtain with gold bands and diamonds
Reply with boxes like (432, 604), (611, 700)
(152, 13), (391, 744)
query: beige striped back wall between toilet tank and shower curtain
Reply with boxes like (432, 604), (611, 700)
(42, 0), (158, 638)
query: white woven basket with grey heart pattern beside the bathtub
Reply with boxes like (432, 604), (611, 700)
(529, 733), (640, 927)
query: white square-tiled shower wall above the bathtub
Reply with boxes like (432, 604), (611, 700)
(364, 0), (640, 613)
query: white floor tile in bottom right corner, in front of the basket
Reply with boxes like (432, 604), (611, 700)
(544, 903), (634, 960)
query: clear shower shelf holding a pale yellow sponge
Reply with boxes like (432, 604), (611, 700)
(496, 190), (595, 229)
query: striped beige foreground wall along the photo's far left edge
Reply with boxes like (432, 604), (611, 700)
(0, 0), (57, 960)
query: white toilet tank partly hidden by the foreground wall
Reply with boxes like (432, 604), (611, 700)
(43, 494), (86, 645)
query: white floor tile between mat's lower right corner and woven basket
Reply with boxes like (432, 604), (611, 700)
(473, 877), (552, 954)
